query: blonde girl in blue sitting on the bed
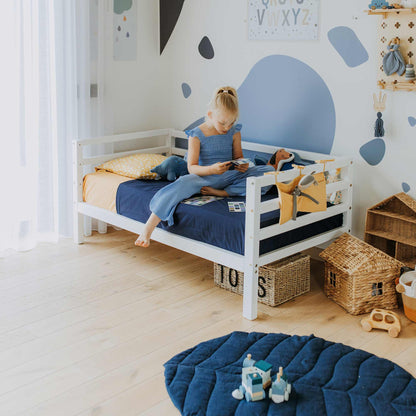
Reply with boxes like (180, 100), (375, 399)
(135, 87), (274, 247)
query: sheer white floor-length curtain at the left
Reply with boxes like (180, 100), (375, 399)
(0, 0), (112, 254)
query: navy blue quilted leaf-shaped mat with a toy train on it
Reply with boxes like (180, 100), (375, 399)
(165, 332), (416, 416)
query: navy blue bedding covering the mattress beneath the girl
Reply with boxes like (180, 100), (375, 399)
(116, 180), (342, 254)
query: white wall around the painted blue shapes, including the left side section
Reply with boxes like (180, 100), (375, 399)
(108, 0), (416, 237)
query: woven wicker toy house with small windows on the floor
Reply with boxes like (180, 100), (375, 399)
(320, 233), (403, 315)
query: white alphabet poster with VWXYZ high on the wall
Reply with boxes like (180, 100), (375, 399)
(248, 0), (320, 40)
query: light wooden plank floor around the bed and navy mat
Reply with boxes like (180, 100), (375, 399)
(0, 228), (416, 416)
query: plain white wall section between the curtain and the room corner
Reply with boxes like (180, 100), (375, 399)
(106, 0), (171, 133)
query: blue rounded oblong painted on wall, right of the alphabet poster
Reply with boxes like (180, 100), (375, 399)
(328, 26), (368, 68)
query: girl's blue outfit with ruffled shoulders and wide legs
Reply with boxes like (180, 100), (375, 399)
(150, 124), (274, 225)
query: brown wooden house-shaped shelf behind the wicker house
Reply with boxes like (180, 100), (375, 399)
(364, 192), (416, 268)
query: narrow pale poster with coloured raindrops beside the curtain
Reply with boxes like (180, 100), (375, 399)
(113, 0), (137, 61)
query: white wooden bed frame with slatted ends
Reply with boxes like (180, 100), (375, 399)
(73, 129), (353, 320)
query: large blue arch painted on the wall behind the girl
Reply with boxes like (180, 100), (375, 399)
(238, 55), (335, 154)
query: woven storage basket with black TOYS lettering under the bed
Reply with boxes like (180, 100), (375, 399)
(214, 253), (310, 306)
